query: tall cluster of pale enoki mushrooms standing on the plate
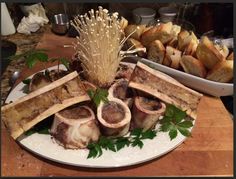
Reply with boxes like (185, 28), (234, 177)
(71, 7), (126, 87)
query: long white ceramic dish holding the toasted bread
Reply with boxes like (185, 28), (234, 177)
(122, 57), (234, 97)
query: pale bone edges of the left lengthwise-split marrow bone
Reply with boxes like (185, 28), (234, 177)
(2, 71), (90, 139)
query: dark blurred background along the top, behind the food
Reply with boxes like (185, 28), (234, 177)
(6, 3), (233, 38)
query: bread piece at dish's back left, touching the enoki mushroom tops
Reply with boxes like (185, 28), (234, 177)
(124, 24), (146, 40)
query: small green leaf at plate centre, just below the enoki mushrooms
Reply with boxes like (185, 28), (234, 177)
(87, 88), (108, 107)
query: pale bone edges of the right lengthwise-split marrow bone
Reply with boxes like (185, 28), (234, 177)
(129, 62), (203, 119)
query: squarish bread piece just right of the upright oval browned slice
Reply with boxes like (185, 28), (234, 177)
(163, 46), (182, 69)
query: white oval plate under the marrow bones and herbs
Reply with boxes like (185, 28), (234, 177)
(6, 67), (195, 168)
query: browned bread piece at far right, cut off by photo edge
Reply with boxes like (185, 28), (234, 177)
(206, 60), (233, 83)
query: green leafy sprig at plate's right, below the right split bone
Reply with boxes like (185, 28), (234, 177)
(160, 105), (193, 140)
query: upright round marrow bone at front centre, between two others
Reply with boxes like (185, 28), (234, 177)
(97, 98), (131, 137)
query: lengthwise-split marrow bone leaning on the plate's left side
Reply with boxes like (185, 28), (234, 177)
(1, 72), (90, 139)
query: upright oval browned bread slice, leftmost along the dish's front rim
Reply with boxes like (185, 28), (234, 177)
(147, 40), (165, 64)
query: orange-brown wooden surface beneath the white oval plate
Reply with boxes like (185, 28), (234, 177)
(1, 32), (233, 176)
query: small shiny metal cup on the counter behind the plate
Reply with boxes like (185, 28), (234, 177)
(52, 14), (69, 35)
